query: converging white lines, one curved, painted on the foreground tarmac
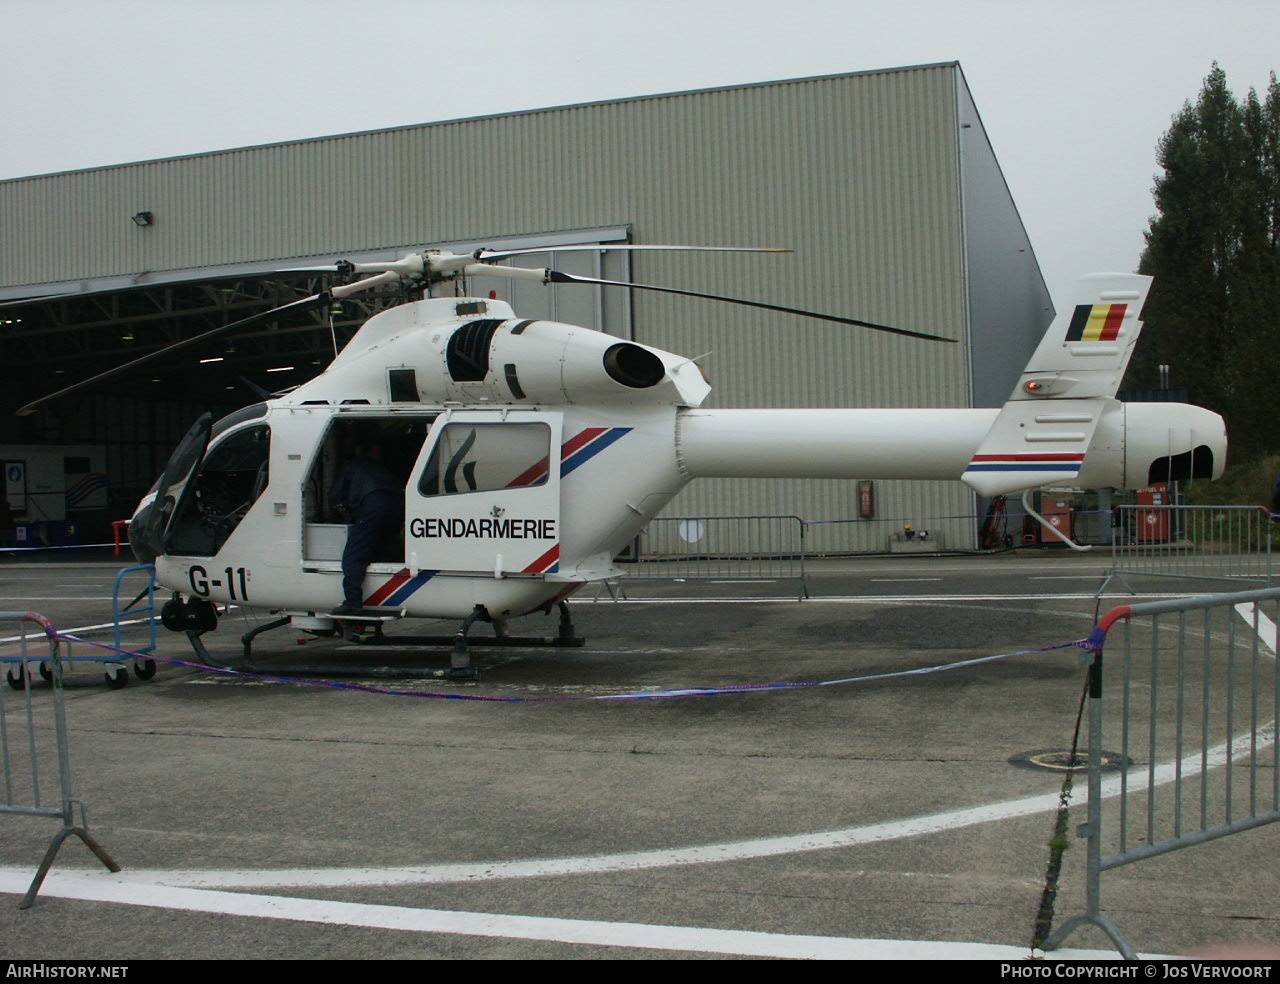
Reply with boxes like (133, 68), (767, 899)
(0, 726), (1249, 960)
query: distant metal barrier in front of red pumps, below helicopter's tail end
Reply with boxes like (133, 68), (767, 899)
(1111, 505), (1280, 585)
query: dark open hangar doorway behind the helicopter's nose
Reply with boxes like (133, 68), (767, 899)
(0, 276), (386, 543)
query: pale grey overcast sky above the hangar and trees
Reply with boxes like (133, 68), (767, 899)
(0, 0), (1280, 296)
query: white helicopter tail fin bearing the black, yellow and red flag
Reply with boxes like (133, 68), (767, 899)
(961, 274), (1151, 496)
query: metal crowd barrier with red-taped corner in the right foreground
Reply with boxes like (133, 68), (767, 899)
(1044, 589), (1280, 960)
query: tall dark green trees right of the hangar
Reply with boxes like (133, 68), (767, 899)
(1126, 63), (1280, 461)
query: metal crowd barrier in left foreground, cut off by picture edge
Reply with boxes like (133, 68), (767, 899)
(0, 612), (120, 909)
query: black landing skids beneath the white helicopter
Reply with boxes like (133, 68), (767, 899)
(187, 601), (586, 679)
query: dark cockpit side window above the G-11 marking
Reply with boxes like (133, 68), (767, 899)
(169, 424), (271, 557)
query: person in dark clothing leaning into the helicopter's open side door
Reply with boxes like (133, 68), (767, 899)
(330, 441), (404, 615)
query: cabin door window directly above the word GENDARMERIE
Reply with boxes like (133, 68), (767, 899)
(417, 424), (552, 495)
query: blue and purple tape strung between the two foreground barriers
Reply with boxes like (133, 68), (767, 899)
(47, 630), (1105, 704)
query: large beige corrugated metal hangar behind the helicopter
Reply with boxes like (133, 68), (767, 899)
(0, 63), (1052, 549)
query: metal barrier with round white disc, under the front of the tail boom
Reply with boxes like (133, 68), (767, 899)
(626, 516), (809, 598)
